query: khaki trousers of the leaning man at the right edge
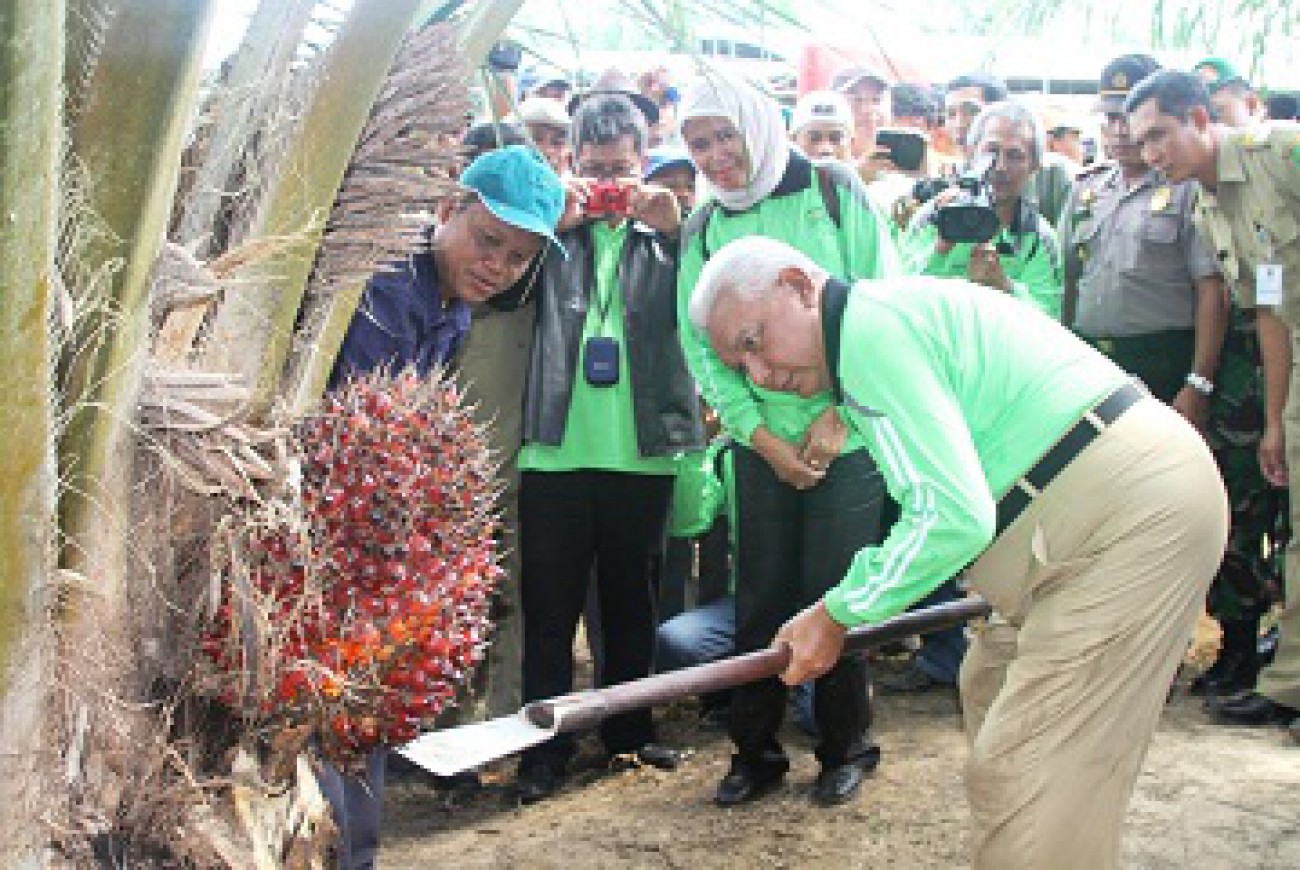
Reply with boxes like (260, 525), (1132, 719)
(1257, 332), (1300, 709)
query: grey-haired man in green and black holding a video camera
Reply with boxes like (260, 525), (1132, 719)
(901, 100), (1062, 320)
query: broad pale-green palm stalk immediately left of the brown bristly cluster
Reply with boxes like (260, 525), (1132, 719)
(203, 0), (423, 419)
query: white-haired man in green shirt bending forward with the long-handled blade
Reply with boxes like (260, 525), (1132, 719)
(690, 237), (1227, 870)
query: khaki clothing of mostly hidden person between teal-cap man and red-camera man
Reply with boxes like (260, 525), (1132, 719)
(458, 304), (536, 722)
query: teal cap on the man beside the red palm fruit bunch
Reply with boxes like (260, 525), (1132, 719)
(460, 146), (566, 255)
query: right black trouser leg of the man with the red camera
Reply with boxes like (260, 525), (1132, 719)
(589, 472), (672, 753)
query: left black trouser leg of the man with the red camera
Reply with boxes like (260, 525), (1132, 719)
(519, 471), (595, 770)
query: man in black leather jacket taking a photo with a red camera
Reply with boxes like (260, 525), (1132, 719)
(517, 92), (703, 804)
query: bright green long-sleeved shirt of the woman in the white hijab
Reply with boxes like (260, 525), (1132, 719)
(677, 168), (898, 453)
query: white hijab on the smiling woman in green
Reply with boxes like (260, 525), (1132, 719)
(677, 70), (790, 212)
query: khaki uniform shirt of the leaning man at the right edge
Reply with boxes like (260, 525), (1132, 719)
(1196, 122), (1300, 329)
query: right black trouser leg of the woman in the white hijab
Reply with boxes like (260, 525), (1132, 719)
(798, 450), (885, 767)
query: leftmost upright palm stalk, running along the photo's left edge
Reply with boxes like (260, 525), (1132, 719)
(0, 0), (64, 866)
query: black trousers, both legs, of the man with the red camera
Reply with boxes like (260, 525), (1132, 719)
(519, 471), (672, 771)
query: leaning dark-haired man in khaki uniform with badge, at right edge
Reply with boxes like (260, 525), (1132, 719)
(1125, 70), (1300, 724)
